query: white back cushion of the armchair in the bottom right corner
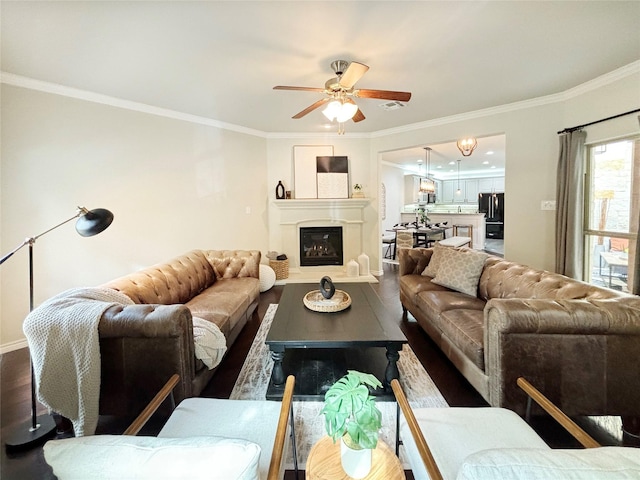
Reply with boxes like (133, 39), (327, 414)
(457, 447), (640, 480)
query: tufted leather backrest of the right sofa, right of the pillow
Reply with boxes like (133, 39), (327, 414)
(478, 257), (625, 301)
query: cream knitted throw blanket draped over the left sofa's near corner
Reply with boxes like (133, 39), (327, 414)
(23, 288), (133, 436)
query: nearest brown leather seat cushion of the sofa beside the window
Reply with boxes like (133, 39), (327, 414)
(439, 309), (484, 371)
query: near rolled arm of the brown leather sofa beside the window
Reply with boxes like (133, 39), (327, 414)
(484, 297), (640, 415)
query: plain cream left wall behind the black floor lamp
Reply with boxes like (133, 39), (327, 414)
(0, 85), (268, 347)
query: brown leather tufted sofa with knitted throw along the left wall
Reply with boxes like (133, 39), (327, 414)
(98, 250), (261, 415)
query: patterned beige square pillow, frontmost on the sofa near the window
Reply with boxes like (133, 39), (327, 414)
(432, 247), (489, 297)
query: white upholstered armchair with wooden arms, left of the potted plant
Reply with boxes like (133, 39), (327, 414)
(44, 375), (297, 480)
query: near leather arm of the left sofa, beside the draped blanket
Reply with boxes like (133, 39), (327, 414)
(98, 305), (195, 415)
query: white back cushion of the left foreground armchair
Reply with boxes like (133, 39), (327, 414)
(44, 435), (260, 480)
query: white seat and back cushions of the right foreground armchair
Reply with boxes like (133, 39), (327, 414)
(400, 407), (640, 480)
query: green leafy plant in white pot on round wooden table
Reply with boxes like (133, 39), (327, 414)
(320, 370), (382, 478)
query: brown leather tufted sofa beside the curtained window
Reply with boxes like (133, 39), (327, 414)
(399, 248), (640, 416)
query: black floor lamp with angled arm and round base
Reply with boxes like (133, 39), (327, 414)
(0, 207), (113, 448)
